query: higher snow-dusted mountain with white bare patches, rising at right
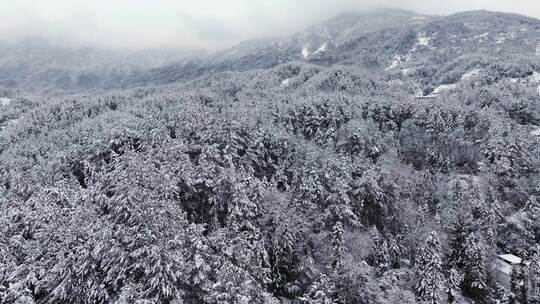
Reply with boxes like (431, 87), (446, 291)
(126, 11), (540, 91)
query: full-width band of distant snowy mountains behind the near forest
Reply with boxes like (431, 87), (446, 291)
(0, 10), (540, 95)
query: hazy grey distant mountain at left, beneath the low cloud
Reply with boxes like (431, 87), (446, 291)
(0, 38), (200, 92)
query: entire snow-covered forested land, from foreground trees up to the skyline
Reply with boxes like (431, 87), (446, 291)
(0, 10), (540, 304)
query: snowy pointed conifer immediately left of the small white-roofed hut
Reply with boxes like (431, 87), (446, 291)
(463, 233), (488, 299)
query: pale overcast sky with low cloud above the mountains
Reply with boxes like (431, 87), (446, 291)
(0, 0), (540, 50)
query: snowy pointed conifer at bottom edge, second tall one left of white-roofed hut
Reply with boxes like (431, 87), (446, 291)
(415, 232), (444, 304)
